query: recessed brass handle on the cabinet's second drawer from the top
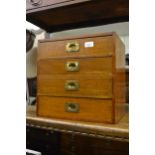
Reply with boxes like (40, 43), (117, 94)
(65, 61), (80, 72)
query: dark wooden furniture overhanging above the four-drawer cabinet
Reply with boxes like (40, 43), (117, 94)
(26, 0), (129, 32)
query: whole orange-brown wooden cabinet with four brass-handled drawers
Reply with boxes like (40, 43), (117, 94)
(37, 33), (125, 123)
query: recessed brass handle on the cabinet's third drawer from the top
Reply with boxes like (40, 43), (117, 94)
(65, 80), (80, 90)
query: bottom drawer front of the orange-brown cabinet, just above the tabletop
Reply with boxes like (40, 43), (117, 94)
(37, 96), (113, 123)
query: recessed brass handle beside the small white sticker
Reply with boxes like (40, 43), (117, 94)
(66, 42), (80, 53)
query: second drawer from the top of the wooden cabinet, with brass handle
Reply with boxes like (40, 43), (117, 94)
(38, 57), (112, 75)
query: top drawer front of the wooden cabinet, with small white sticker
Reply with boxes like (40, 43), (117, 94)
(38, 36), (114, 60)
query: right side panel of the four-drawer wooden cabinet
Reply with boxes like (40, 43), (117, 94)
(113, 34), (126, 122)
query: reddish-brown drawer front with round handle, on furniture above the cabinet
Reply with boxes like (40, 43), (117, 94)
(26, 0), (70, 10)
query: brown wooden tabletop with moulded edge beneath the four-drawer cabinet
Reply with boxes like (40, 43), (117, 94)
(26, 104), (129, 142)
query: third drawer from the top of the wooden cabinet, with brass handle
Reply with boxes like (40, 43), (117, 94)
(38, 74), (112, 98)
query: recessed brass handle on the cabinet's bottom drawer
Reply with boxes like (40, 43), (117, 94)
(65, 103), (80, 113)
